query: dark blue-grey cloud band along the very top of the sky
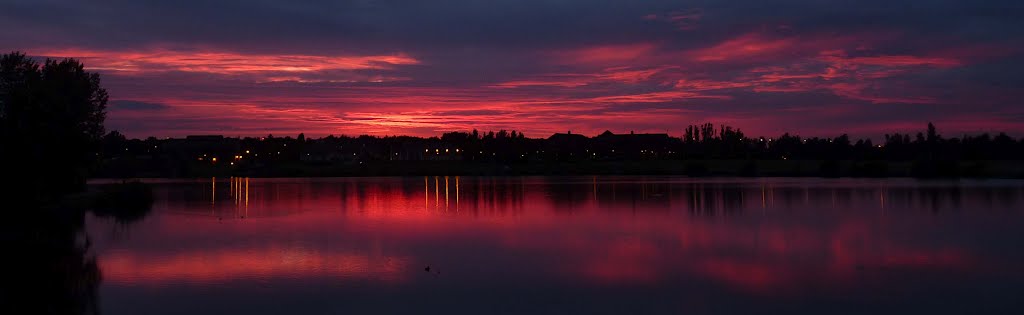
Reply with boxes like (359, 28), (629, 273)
(0, 0), (1024, 52)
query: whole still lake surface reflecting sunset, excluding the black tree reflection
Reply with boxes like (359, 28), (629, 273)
(86, 177), (1024, 314)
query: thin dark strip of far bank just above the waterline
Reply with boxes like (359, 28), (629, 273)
(92, 160), (1024, 180)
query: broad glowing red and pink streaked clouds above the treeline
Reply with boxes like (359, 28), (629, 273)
(61, 24), (1007, 137)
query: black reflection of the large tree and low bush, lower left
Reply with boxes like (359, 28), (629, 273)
(0, 183), (153, 314)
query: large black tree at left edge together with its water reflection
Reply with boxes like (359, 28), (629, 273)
(0, 52), (153, 314)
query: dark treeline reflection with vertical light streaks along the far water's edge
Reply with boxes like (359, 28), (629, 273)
(157, 176), (1021, 219)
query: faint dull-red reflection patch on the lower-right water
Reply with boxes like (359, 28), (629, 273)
(569, 217), (978, 294)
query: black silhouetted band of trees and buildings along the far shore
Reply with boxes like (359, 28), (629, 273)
(100, 124), (1024, 177)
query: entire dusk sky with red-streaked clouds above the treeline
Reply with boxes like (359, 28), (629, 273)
(0, 0), (1024, 137)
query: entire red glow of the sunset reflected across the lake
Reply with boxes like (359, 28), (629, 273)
(90, 179), (1015, 295)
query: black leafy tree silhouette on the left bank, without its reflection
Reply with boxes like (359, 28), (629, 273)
(0, 52), (108, 198)
